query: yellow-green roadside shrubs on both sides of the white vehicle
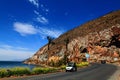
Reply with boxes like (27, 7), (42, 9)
(0, 62), (90, 79)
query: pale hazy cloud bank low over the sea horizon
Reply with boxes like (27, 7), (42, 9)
(0, 45), (35, 61)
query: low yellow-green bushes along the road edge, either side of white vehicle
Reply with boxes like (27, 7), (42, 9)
(0, 62), (89, 78)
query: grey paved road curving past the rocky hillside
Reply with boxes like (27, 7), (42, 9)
(6, 64), (117, 80)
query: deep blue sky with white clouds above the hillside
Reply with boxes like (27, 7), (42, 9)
(0, 0), (120, 61)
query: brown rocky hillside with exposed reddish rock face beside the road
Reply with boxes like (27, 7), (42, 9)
(25, 11), (120, 65)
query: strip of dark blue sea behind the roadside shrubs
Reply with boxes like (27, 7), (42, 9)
(0, 61), (35, 69)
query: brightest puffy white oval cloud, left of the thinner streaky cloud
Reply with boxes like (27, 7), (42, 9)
(13, 22), (37, 36)
